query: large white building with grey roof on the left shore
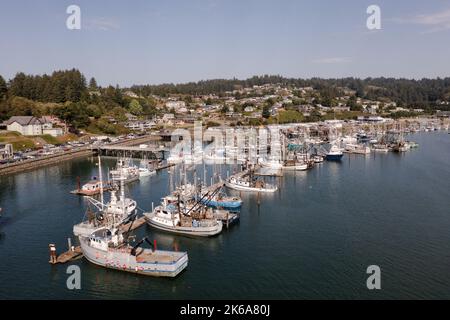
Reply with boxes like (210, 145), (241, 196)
(4, 116), (64, 137)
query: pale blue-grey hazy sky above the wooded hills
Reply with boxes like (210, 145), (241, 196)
(0, 0), (450, 86)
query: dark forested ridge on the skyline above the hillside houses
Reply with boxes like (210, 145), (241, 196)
(130, 75), (450, 108)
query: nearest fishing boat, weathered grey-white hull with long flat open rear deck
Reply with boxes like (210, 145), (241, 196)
(80, 227), (188, 278)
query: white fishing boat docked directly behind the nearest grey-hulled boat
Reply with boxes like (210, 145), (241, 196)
(144, 198), (223, 237)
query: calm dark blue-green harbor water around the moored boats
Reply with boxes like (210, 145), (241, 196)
(0, 132), (450, 299)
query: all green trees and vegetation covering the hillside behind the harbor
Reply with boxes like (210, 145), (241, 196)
(0, 69), (450, 134)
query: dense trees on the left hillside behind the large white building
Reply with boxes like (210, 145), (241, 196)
(0, 69), (162, 134)
